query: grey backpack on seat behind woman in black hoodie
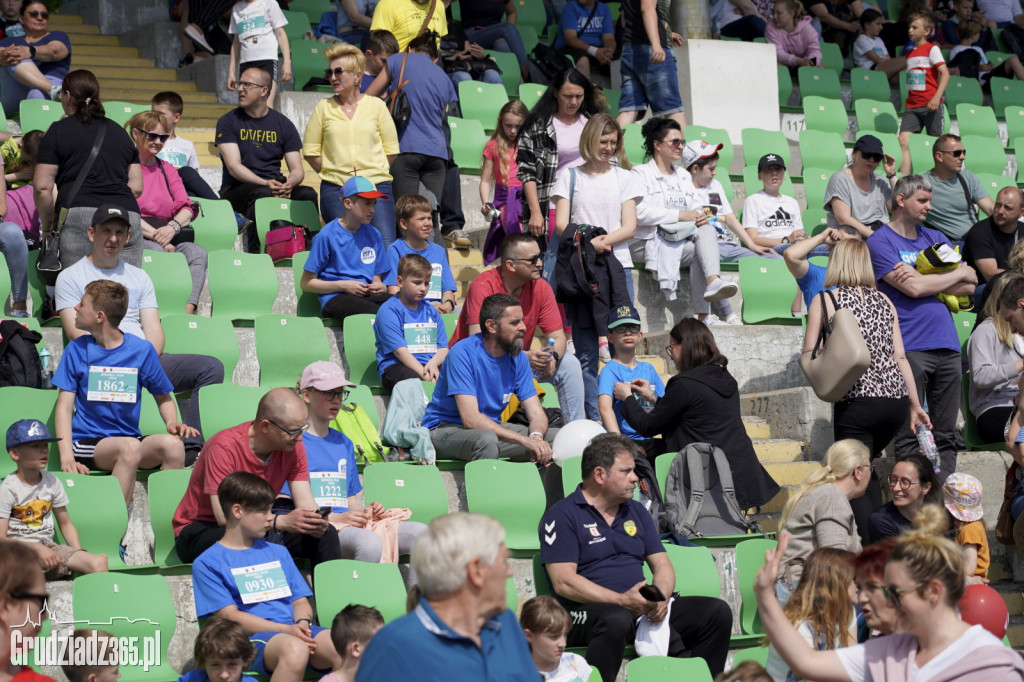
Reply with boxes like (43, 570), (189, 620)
(664, 442), (761, 538)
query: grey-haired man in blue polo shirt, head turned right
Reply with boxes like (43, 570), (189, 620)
(355, 513), (541, 682)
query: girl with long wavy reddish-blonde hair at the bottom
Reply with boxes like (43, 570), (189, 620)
(765, 547), (857, 682)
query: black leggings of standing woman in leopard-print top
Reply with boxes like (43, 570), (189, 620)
(833, 397), (910, 546)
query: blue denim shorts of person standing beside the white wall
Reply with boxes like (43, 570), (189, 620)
(618, 43), (683, 116)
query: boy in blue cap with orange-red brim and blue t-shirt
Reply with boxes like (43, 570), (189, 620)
(299, 175), (389, 322)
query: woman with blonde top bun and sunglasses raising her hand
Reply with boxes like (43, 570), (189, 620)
(754, 505), (1024, 682)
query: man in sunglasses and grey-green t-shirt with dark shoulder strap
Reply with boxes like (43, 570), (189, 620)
(921, 135), (994, 242)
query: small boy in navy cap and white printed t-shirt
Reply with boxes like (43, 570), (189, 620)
(0, 419), (106, 579)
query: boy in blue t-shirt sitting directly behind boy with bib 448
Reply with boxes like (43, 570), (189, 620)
(384, 195), (455, 313)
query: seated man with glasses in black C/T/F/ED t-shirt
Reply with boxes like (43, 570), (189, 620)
(214, 68), (318, 253)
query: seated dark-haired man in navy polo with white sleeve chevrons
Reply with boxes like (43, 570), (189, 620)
(540, 433), (732, 680)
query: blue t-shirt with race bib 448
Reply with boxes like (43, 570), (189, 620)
(374, 294), (447, 377)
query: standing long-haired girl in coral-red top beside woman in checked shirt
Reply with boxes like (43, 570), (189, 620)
(480, 99), (528, 265)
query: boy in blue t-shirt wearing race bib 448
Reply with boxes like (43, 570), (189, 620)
(374, 253), (447, 391)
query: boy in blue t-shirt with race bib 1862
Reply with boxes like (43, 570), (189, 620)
(53, 280), (199, 505)
